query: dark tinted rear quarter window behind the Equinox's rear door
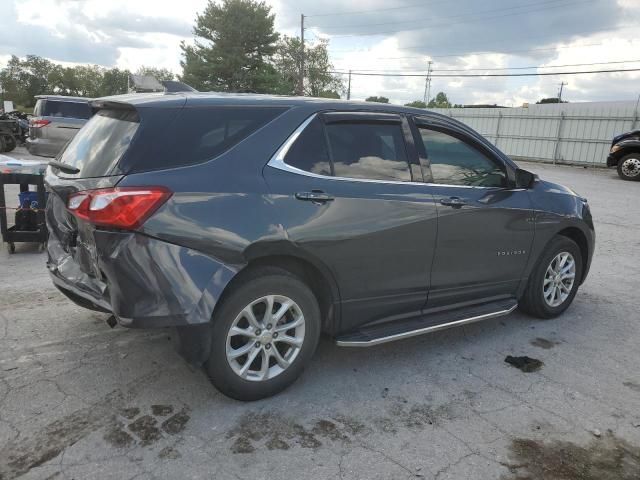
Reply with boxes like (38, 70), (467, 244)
(120, 107), (287, 173)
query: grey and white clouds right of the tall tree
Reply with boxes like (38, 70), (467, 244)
(278, 0), (640, 105)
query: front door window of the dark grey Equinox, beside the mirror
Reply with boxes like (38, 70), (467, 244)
(420, 127), (507, 187)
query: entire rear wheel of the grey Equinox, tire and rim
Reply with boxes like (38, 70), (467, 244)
(205, 267), (320, 401)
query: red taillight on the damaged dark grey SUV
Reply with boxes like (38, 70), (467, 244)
(67, 187), (171, 230)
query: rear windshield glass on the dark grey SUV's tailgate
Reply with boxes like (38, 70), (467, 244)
(59, 110), (140, 178)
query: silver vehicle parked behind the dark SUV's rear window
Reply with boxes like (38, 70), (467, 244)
(27, 95), (93, 157)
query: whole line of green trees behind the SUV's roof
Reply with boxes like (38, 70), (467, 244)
(0, 0), (345, 107)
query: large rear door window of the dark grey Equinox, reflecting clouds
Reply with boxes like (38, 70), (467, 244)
(325, 122), (411, 182)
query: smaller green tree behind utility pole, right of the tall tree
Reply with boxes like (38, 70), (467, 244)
(273, 36), (345, 98)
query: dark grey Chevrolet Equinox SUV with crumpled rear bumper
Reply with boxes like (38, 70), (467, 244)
(46, 93), (594, 400)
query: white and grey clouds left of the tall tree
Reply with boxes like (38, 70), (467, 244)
(0, 0), (195, 68)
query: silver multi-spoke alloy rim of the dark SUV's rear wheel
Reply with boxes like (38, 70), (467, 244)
(226, 295), (305, 382)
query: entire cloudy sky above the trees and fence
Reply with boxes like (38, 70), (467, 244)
(0, 0), (640, 106)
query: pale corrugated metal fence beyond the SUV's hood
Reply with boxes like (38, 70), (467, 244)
(434, 102), (640, 166)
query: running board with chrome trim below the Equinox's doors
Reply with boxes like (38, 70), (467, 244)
(336, 300), (518, 347)
